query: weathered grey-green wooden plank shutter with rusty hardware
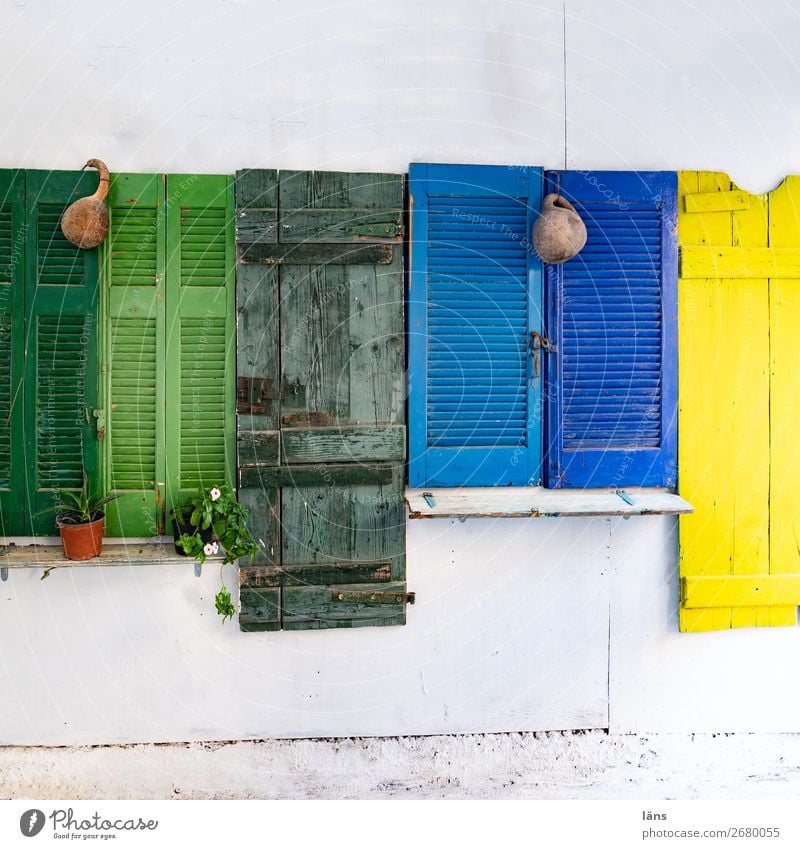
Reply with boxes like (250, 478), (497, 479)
(237, 171), (407, 631)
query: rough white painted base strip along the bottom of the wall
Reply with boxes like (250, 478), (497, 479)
(0, 731), (800, 799)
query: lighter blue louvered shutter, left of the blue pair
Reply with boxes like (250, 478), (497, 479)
(409, 164), (543, 486)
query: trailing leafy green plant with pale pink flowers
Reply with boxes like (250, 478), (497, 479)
(170, 484), (260, 622)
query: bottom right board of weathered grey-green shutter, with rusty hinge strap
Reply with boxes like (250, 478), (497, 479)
(282, 583), (406, 630)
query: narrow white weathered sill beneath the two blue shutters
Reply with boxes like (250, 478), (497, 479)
(406, 486), (694, 519)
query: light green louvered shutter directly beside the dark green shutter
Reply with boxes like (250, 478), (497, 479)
(103, 174), (167, 536)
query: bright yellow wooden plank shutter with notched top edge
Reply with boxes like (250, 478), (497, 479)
(678, 171), (800, 631)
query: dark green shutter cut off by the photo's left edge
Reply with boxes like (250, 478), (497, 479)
(0, 170), (25, 536)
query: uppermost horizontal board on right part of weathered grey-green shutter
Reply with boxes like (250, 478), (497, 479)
(279, 206), (403, 243)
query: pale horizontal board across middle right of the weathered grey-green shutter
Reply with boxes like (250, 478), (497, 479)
(281, 425), (406, 463)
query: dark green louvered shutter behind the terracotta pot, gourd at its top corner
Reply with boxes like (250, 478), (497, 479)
(24, 171), (99, 534)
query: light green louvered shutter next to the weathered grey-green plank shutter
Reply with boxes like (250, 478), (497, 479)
(166, 169), (236, 506)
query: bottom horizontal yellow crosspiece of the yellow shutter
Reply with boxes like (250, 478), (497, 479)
(681, 574), (800, 608)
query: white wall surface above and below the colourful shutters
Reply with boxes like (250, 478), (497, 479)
(0, 0), (800, 743)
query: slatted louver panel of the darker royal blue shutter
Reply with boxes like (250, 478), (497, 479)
(561, 201), (661, 451)
